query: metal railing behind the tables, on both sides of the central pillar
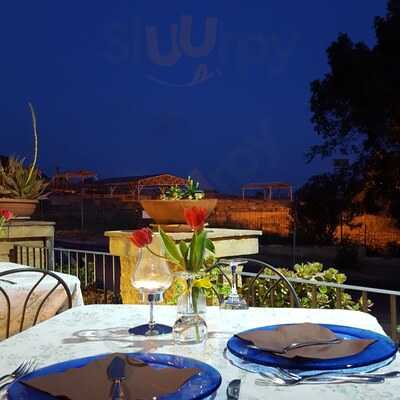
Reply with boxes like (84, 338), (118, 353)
(14, 245), (400, 343)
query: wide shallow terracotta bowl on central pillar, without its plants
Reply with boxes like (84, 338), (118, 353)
(140, 199), (218, 225)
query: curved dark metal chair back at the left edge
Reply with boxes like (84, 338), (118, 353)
(0, 268), (72, 338)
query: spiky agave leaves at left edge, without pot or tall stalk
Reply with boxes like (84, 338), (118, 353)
(0, 157), (48, 200)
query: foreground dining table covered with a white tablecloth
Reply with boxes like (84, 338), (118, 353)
(0, 304), (400, 400)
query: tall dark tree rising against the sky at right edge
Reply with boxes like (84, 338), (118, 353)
(308, 0), (400, 225)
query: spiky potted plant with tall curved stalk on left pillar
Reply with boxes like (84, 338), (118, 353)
(0, 103), (47, 218)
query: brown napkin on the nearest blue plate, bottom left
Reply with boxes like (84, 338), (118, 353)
(23, 354), (200, 400)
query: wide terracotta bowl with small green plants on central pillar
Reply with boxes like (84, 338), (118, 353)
(140, 176), (218, 230)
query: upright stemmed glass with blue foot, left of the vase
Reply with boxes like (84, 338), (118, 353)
(129, 248), (173, 336)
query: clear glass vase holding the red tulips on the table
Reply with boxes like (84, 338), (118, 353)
(173, 272), (207, 344)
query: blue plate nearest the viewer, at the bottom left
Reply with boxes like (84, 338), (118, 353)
(8, 353), (221, 400)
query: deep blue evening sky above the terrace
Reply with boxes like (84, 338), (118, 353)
(0, 0), (386, 192)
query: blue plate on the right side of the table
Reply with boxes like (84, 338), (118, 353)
(227, 324), (397, 371)
